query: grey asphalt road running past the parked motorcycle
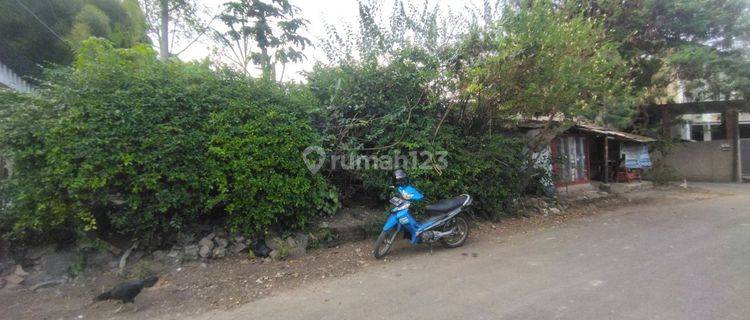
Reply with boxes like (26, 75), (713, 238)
(192, 185), (750, 320)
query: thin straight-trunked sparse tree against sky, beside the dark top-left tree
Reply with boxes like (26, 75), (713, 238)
(140, 0), (213, 61)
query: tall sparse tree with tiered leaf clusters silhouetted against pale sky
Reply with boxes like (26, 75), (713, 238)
(214, 0), (311, 80)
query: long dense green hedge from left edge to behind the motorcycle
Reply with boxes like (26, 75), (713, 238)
(0, 39), (536, 244)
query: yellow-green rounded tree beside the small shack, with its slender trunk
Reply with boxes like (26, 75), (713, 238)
(463, 4), (638, 188)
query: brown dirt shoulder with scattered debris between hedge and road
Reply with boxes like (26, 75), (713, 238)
(0, 188), (724, 319)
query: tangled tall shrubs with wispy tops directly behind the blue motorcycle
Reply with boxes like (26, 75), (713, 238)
(308, 4), (552, 217)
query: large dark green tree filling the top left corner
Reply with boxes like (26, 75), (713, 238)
(0, 0), (148, 68)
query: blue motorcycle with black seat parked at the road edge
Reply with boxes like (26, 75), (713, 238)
(373, 170), (472, 259)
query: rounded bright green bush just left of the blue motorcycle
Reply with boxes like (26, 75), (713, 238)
(208, 101), (338, 234)
